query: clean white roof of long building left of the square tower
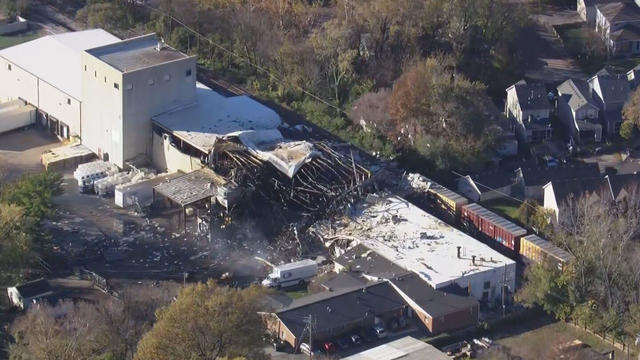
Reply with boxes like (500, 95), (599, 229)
(0, 29), (120, 100)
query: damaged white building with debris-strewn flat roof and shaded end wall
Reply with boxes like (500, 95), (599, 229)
(323, 196), (516, 301)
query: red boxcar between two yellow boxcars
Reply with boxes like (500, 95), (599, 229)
(461, 203), (527, 253)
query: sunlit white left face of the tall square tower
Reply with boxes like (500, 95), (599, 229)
(80, 52), (125, 167)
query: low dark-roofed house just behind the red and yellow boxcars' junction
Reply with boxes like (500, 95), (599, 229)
(457, 170), (516, 202)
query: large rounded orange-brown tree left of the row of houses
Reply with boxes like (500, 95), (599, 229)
(389, 58), (494, 168)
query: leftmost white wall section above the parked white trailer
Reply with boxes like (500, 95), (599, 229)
(0, 57), (38, 107)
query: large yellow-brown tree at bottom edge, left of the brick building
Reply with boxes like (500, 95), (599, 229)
(134, 281), (266, 360)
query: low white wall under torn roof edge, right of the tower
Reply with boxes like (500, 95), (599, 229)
(151, 132), (203, 173)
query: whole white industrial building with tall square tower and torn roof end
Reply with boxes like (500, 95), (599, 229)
(0, 29), (280, 171)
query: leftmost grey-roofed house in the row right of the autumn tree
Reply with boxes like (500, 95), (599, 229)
(505, 80), (552, 143)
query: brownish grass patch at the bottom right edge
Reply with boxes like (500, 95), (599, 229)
(497, 321), (626, 360)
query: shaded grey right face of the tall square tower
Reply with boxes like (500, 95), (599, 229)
(122, 57), (196, 160)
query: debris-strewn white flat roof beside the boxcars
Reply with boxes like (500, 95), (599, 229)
(337, 196), (514, 288)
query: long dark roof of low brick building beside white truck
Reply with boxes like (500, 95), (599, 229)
(276, 281), (407, 336)
